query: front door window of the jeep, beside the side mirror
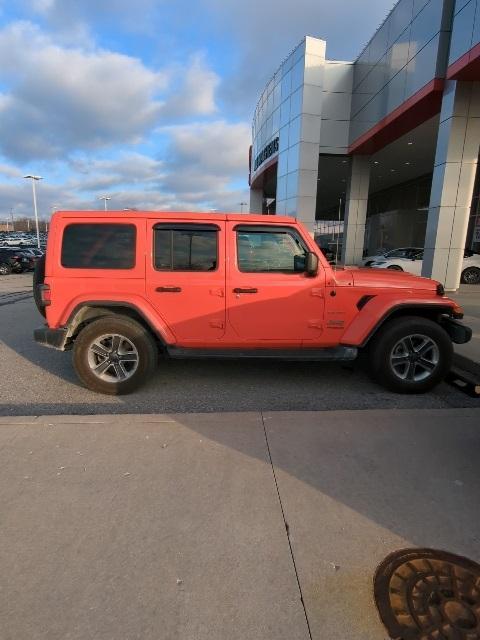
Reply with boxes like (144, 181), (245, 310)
(237, 227), (307, 273)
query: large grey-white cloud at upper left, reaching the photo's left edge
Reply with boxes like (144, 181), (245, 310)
(0, 22), (219, 161)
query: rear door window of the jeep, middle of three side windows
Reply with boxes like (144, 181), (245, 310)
(154, 223), (218, 271)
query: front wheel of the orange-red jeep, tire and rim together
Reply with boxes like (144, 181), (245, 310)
(369, 316), (453, 393)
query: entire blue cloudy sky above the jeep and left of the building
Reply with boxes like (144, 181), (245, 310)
(0, 0), (392, 221)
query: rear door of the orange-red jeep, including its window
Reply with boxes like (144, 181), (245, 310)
(146, 218), (225, 347)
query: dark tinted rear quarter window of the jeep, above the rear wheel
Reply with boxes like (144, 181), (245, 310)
(61, 223), (136, 269)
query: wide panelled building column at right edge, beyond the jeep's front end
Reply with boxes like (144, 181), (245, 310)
(422, 80), (480, 291)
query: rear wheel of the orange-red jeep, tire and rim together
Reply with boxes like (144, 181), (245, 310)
(73, 315), (158, 395)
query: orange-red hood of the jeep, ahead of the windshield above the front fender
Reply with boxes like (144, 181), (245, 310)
(335, 267), (439, 292)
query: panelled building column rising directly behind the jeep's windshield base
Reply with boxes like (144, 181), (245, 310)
(342, 156), (370, 264)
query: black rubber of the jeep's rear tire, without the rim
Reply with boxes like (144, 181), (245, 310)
(73, 316), (158, 395)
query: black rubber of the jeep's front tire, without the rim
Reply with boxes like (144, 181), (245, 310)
(369, 316), (453, 393)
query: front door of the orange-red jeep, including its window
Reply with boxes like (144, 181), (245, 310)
(226, 222), (325, 346)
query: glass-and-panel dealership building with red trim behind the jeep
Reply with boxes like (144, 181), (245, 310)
(250, 0), (480, 290)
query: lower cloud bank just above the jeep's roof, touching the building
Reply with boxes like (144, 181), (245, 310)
(65, 120), (250, 210)
